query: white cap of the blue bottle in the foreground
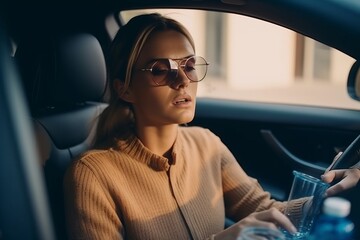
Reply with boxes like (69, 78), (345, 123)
(323, 197), (351, 217)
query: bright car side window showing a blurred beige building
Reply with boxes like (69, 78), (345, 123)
(119, 9), (360, 109)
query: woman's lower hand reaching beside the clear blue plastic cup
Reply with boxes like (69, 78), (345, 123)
(214, 208), (297, 240)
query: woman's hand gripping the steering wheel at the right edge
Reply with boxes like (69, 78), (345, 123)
(321, 152), (360, 196)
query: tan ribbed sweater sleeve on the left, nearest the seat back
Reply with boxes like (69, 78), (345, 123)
(64, 160), (124, 240)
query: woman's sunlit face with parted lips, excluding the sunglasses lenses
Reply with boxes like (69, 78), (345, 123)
(128, 30), (197, 127)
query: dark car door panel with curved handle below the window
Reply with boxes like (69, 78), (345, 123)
(190, 98), (360, 233)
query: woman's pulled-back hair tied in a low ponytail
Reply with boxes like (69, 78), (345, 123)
(94, 13), (195, 147)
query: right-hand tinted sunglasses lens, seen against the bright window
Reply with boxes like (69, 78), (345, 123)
(182, 56), (208, 82)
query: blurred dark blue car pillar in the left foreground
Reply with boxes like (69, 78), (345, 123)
(0, 23), (54, 239)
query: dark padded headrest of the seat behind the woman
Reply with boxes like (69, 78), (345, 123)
(15, 34), (106, 112)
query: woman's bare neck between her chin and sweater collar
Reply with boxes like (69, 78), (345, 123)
(137, 124), (179, 158)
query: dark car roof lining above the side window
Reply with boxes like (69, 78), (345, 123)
(3, 0), (360, 59)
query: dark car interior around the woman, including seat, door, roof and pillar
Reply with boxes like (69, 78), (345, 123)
(0, 0), (360, 240)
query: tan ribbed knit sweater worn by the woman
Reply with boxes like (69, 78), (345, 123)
(64, 127), (296, 240)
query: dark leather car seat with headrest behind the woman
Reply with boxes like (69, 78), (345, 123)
(15, 33), (106, 239)
